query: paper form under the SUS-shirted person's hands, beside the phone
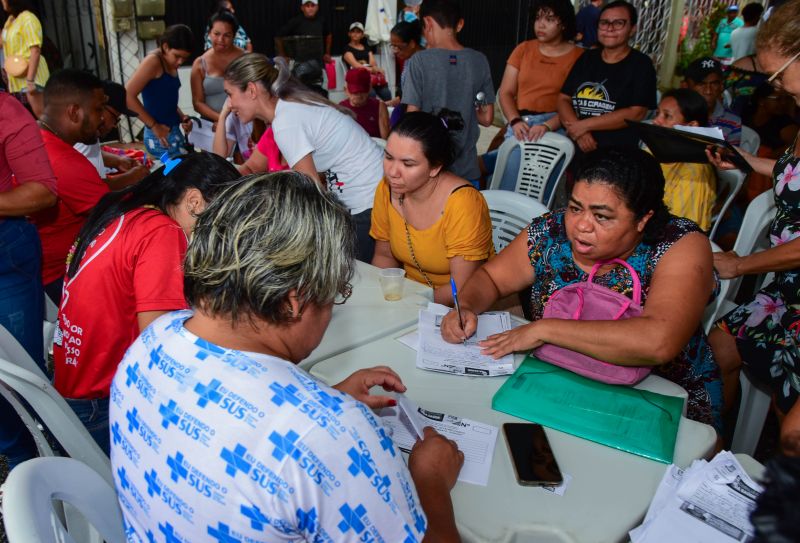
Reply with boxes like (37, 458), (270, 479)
(378, 407), (497, 486)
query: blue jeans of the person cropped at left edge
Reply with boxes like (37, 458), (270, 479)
(0, 218), (45, 469)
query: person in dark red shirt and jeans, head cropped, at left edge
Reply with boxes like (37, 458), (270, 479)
(0, 92), (56, 468)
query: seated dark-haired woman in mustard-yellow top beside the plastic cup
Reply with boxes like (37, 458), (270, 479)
(369, 110), (494, 305)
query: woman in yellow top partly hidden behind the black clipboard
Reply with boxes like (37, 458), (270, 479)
(653, 89), (717, 232)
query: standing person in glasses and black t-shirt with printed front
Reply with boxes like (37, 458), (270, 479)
(557, 0), (656, 153)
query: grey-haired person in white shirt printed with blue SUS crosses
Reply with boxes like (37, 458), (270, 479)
(111, 172), (464, 543)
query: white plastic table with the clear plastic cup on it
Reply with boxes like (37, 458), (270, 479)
(300, 261), (433, 369)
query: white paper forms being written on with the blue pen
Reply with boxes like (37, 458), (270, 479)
(417, 304), (514, 377)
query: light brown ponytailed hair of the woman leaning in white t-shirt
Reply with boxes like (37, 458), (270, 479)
(225, 53), (354, 117)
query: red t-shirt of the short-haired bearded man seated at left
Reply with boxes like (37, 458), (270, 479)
(31, 129), (109, 285)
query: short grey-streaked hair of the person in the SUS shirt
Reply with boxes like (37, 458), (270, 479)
(184, 172), (355, 324)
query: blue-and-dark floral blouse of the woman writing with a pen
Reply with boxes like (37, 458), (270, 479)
(528, 209), (722, 430)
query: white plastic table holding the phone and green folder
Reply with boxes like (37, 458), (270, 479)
(311, 327), (716, 543)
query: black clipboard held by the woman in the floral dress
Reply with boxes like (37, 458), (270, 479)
(625, 119), (753, 173)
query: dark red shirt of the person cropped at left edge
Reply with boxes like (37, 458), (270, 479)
(0, 92), (56, 196)
